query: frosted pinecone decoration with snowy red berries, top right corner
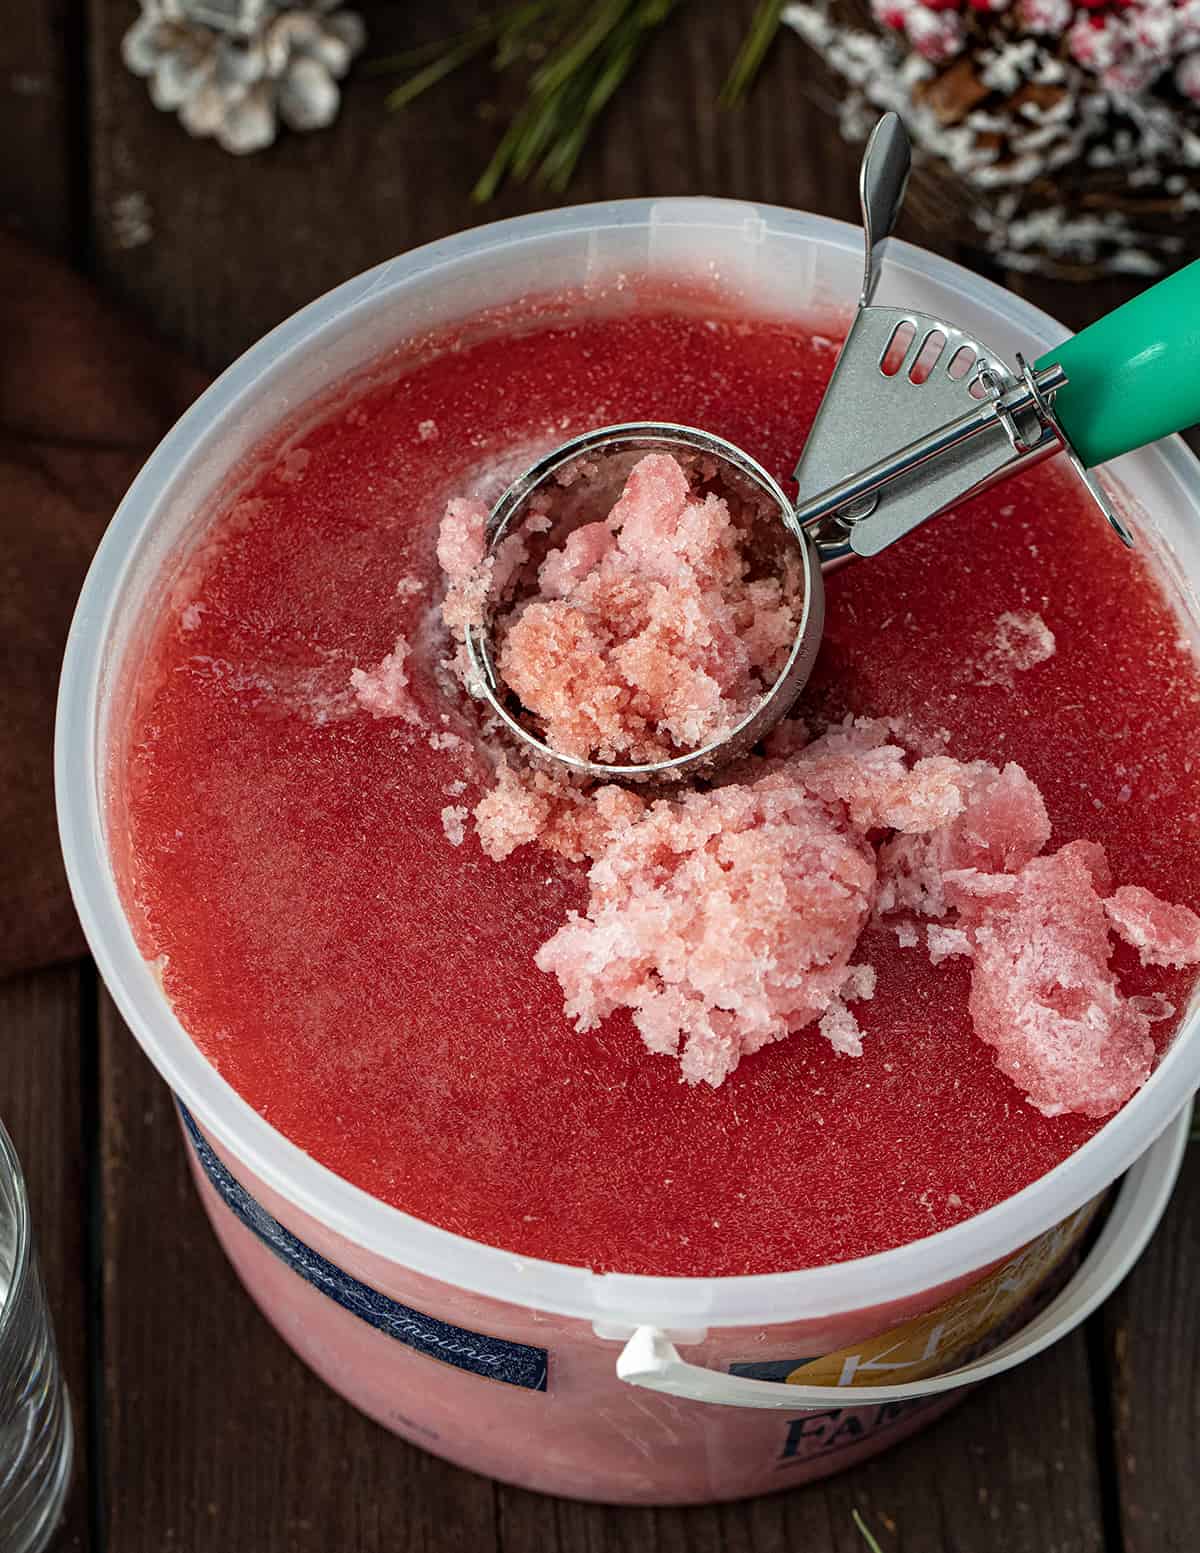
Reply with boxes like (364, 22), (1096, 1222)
(784, 0), (1200, 278)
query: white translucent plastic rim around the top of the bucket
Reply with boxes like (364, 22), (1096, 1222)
(54, 199), (1200, 1329)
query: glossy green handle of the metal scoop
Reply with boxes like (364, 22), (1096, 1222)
(1034, 259), (1200, 469)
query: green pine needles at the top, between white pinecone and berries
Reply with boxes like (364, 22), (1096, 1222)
(376, 0), (784, 203)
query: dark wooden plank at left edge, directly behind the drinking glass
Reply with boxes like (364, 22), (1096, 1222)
(0, 964), (92, 1553)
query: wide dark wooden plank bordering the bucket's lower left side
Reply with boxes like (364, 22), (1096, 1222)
(99, 997), (497, 1553)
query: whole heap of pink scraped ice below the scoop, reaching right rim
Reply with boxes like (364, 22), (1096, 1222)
(537, 721), (1200, 1117)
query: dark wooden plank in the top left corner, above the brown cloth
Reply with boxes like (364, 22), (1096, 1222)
(0, 0), (84, 253)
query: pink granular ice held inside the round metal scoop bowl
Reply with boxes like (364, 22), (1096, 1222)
(438, 453), (796, 764)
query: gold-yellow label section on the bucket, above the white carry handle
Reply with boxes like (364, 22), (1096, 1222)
(787, 1193), (1105, 1385)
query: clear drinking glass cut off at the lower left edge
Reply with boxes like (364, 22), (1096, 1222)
(0, 1123), (71, 1553)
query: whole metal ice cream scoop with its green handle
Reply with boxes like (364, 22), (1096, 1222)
(466, 113), (1200, 781)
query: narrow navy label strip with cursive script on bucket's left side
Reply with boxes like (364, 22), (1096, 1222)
(179, 1103), (548, 1391)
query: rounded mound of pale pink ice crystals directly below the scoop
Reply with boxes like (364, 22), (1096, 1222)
(537, 772), (876, 1086)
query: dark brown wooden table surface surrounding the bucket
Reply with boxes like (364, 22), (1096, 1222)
(0, 0), (1200, 1553)
